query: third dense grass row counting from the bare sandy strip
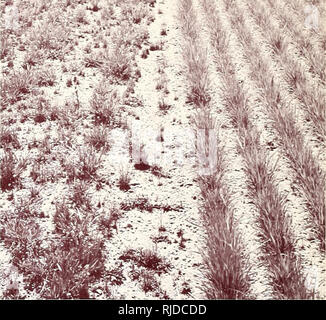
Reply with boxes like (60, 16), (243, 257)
(224, 0), (325, 251)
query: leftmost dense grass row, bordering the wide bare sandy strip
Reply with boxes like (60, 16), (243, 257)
(179, 0), (250, 299)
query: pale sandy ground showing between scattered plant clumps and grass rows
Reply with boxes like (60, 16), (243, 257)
(0, 0), (326, 299)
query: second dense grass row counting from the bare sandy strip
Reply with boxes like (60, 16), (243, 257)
(203, 0), (309, 299)
